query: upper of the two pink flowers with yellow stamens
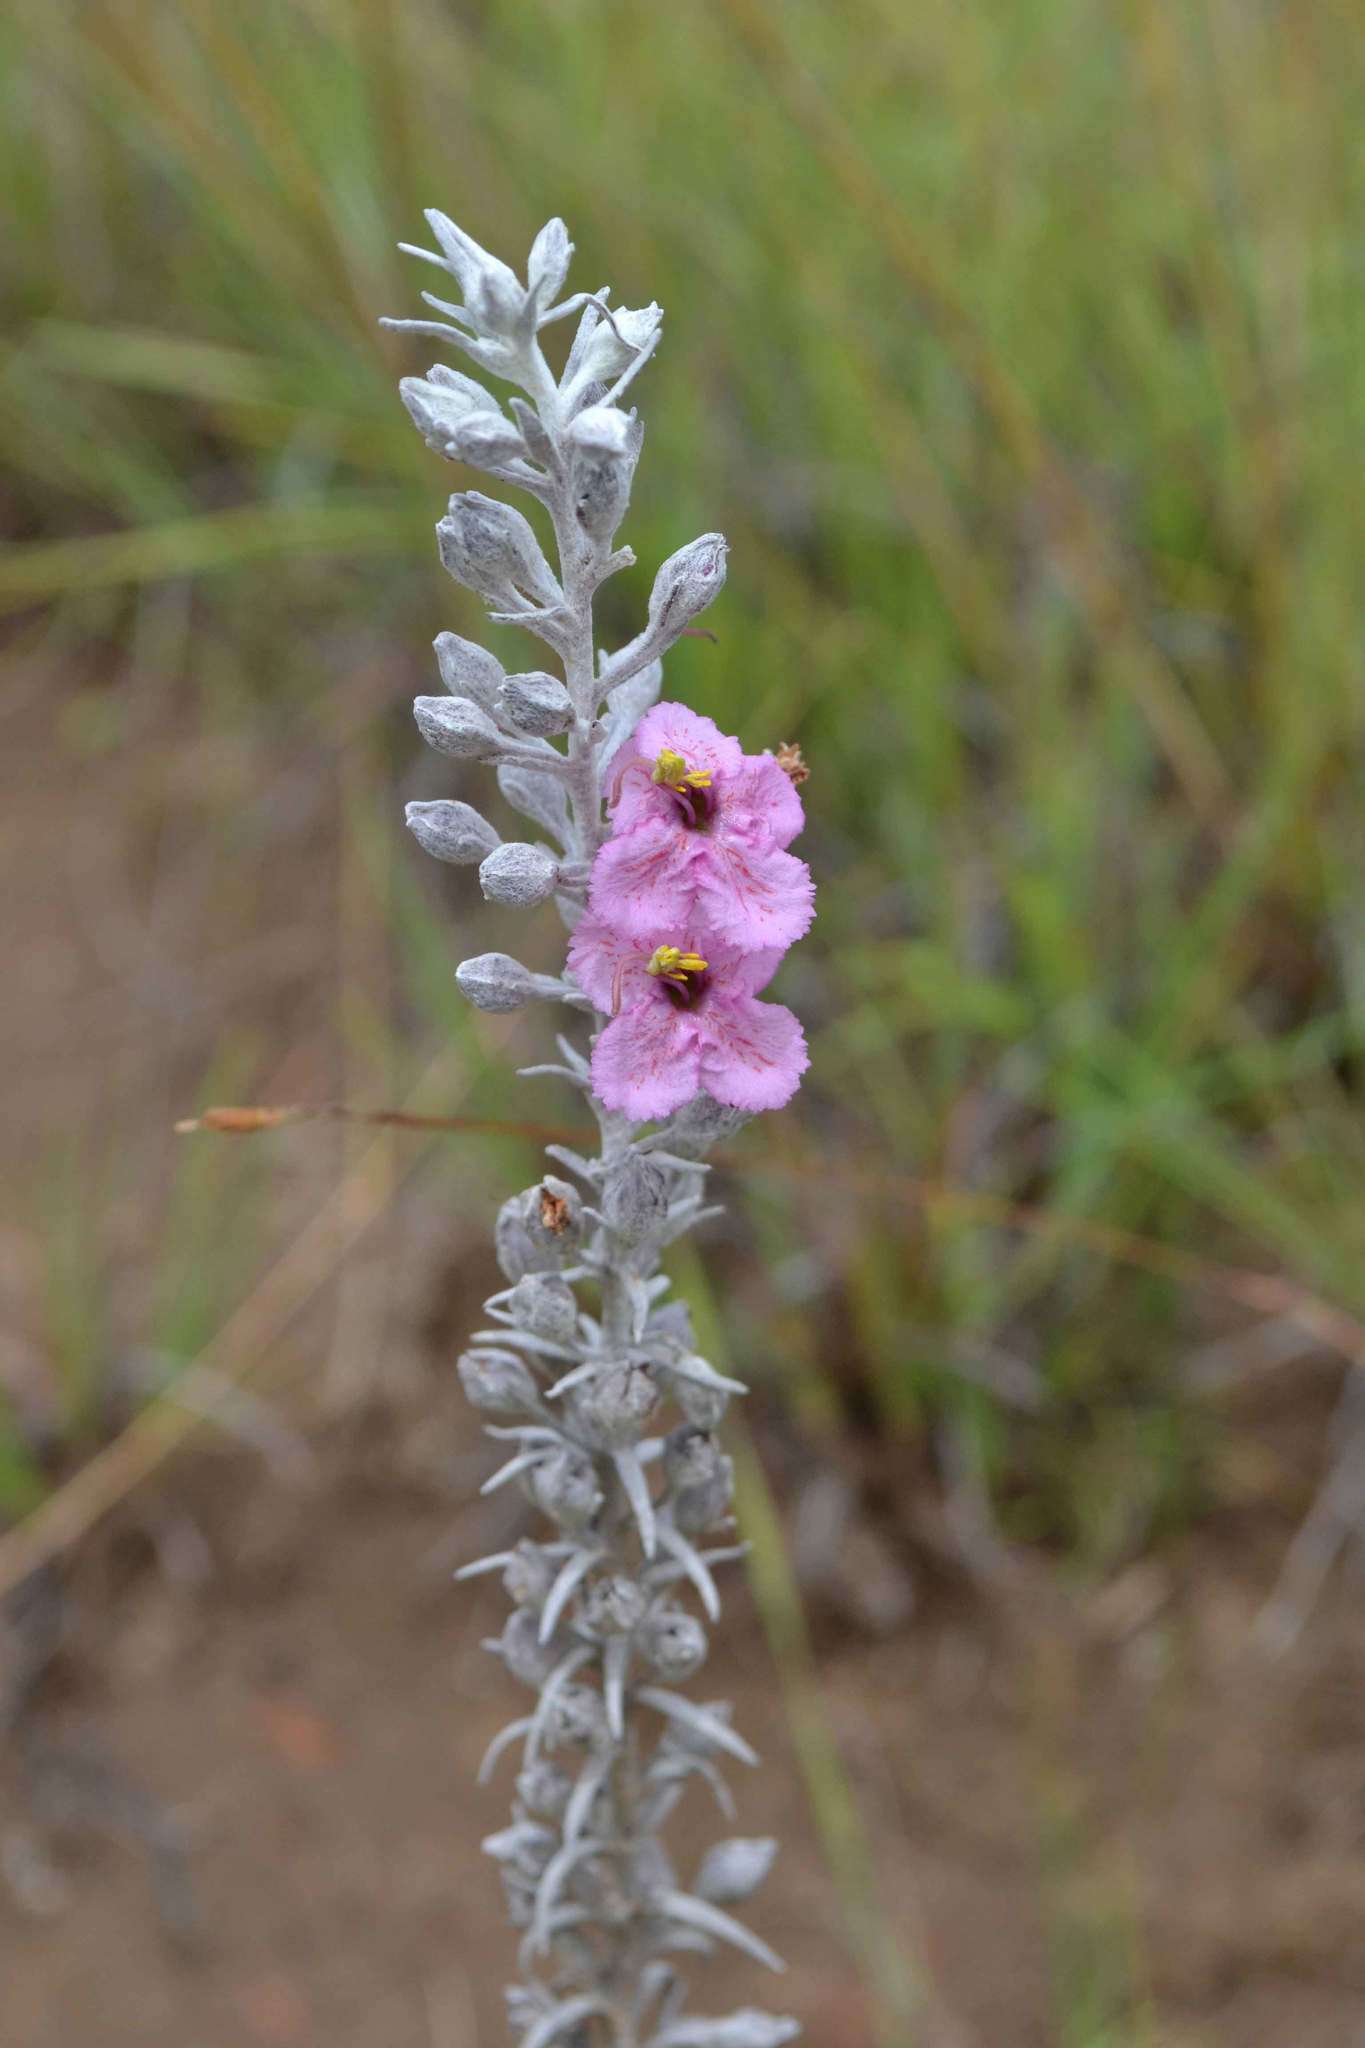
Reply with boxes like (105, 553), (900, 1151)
(589, 705), (814, 950)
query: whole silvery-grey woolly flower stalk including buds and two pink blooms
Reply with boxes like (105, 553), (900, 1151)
(387, 213), (812, 2048)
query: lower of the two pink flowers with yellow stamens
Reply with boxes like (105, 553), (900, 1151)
(569, 911), (808, 1116)
